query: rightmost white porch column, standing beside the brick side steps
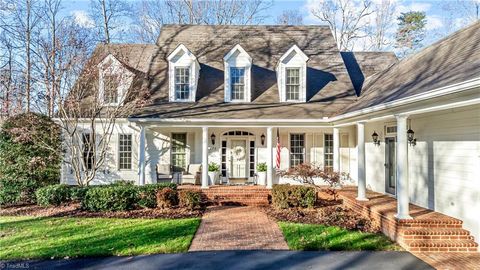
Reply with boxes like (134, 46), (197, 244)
(395, 114), (412, 219)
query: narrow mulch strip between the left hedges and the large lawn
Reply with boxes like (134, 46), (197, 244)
(0, 203), (204, 219)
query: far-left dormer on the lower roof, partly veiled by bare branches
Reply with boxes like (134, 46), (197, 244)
(97, 54), (135, 106)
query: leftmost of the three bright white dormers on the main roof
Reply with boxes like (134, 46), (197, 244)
(167, 44), (200, 102)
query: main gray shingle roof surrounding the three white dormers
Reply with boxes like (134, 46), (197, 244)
(131, 25), (355, 119)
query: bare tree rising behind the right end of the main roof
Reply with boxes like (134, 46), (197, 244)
(311, 0), (373, 50)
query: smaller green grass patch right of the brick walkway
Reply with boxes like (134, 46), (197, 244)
(279, 222), (401, 251)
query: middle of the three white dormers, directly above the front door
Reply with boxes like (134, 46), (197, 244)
(223, 44), (252, 102)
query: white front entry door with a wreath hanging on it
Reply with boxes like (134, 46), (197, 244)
(230, 139), (247, 178)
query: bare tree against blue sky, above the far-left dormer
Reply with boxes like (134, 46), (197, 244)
(90, 0), (131, 44)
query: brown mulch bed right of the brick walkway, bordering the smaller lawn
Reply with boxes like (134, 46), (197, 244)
(262, 201), (380, 233)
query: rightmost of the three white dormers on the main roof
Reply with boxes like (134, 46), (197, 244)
(277, 45), (308, 102)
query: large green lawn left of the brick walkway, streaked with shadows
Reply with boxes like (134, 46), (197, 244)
(0, 217), (200, 260)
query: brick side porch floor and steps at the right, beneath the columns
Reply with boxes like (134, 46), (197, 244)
(339, 187), (478, 252)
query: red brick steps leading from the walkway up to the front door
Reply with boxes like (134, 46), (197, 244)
(180, 186), (271, 206)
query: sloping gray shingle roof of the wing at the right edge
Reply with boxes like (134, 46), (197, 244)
(342, 22), (480, 112)
